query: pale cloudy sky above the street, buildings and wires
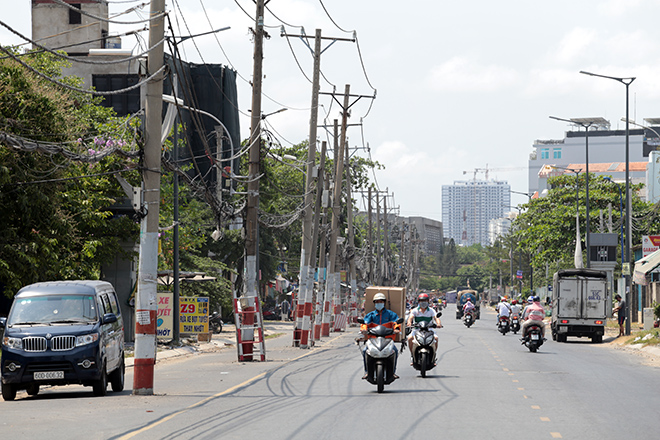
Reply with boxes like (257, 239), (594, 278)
(0, 0), (660, 220)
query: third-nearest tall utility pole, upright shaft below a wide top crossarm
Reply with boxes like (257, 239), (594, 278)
(293, 29), (321, 348)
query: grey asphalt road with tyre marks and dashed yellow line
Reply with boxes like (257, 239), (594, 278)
(0, 306), (660, 440)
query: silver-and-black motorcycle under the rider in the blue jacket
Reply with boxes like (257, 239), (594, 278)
(356, 317), (403, 393)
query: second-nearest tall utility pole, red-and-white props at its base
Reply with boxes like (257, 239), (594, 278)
(242, 0), (264, 361)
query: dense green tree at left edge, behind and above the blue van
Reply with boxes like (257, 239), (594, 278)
(0, 47), (137, 296)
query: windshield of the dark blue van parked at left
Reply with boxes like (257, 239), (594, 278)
(7, 295), (98, 325)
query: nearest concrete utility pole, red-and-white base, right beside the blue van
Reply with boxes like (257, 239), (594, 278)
(133, 0), (165, 395)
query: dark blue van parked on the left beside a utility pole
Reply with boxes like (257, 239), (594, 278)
(0, 281), (125, 400)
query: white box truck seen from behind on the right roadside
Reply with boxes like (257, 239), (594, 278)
(550, 269), (612, 343)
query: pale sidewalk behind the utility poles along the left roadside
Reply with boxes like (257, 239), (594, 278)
(125, 321), (294, 368)
